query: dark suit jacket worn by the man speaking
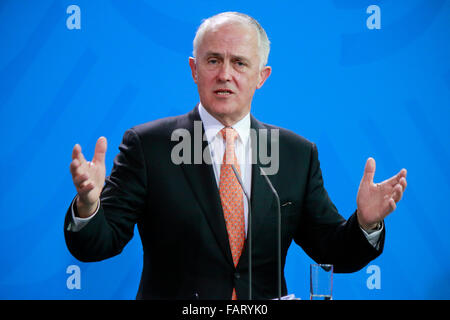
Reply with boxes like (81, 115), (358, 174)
(64, 108), (384, 299)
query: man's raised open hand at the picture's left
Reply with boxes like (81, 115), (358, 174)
(70, 137), (107, 218)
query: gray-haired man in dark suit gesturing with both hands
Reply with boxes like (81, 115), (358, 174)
(64, 12), (406, 299)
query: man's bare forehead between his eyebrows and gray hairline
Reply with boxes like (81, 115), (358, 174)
(198, 21), (258, 58)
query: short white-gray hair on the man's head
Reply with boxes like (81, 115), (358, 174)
(192, 12), (270, 69)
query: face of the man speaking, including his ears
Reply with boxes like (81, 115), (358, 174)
(189, 21), (271, 126)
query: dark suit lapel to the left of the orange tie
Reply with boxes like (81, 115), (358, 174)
(181, 107), (234, 266)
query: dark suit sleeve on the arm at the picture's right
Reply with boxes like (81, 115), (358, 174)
(295, 144), (384, 272)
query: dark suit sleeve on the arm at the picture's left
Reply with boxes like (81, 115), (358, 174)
(64, 129), (147, 261)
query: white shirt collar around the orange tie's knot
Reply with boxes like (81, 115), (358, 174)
(198, 103), (250, 145)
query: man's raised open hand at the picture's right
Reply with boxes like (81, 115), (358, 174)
(356, 158), (406, 230)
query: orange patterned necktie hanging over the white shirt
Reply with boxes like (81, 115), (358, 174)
(219, 128), (245, 300)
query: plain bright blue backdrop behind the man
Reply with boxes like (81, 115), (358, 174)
(0, 0), (450, 299)
